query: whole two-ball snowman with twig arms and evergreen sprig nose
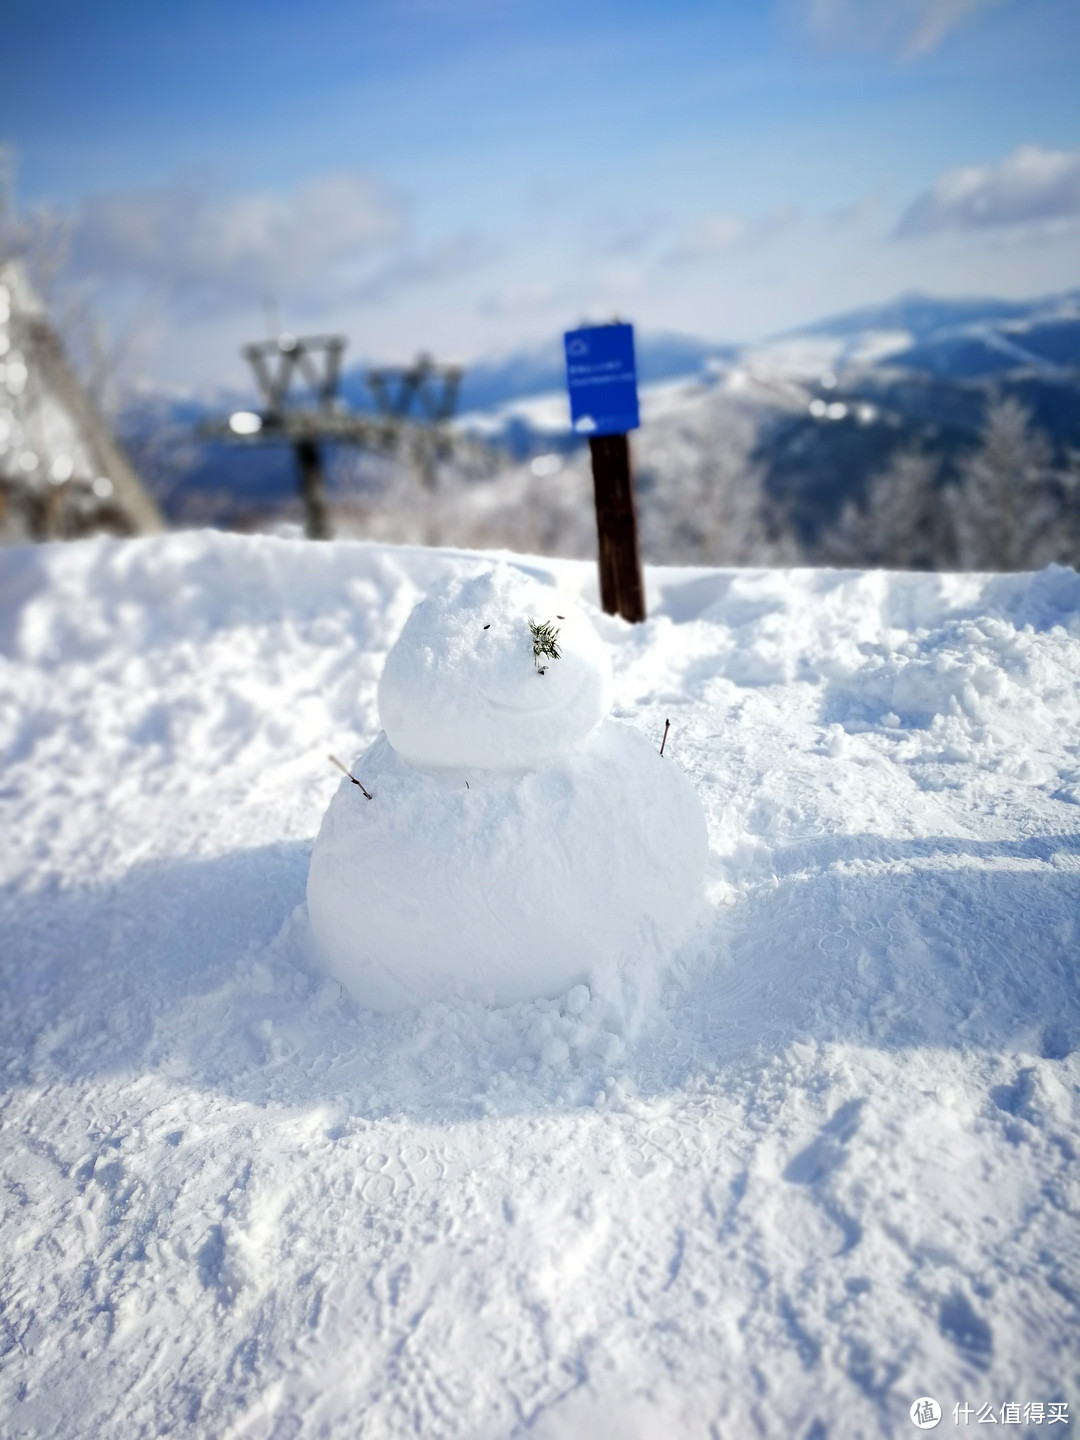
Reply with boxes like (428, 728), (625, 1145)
(307, 564), (707, 1011)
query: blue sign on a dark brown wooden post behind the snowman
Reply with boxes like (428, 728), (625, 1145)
(564, 324), (645, 624)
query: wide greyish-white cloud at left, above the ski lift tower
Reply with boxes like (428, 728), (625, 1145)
(73, 171), (403, 304)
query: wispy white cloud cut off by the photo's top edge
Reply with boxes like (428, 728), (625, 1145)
(782, 0), (1005, 59)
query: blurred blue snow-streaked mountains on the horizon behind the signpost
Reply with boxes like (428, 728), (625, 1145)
(116, 292), (1080, 540)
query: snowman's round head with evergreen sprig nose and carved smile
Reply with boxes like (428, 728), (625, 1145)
(379, 564), (612, 770)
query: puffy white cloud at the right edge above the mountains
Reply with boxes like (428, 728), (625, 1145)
(896, 145), (1080, 236)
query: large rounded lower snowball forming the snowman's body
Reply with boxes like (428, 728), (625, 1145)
(308, 720), (707, 1009)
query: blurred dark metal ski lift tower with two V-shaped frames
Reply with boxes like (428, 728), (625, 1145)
(202, 334), (462, 540)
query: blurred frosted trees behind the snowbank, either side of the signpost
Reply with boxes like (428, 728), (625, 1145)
(315, 396), (1080, 570)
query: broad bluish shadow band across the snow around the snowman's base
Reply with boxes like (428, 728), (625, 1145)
(0, 835), (1080, 1117)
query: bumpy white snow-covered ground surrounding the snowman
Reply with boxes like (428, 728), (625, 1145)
(0, 534), (1080, 1440)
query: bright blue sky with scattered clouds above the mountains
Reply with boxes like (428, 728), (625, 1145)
(0, 0), (1080, 383)
